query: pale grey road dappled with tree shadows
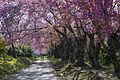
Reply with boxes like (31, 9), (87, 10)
(9, 60), (60, 80)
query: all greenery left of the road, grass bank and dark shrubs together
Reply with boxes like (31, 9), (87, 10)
(0, 38), (36, 79)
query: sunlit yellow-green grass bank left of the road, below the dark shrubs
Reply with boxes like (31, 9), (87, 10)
(0, 57), (36, 79)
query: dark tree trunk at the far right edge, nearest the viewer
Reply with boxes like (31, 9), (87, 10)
(108, 34), (120, 78)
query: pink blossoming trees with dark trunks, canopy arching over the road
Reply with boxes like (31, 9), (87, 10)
(0, 0), (120, 76)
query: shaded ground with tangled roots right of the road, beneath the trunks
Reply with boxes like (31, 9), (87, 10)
(50, 59), (120, 80)
